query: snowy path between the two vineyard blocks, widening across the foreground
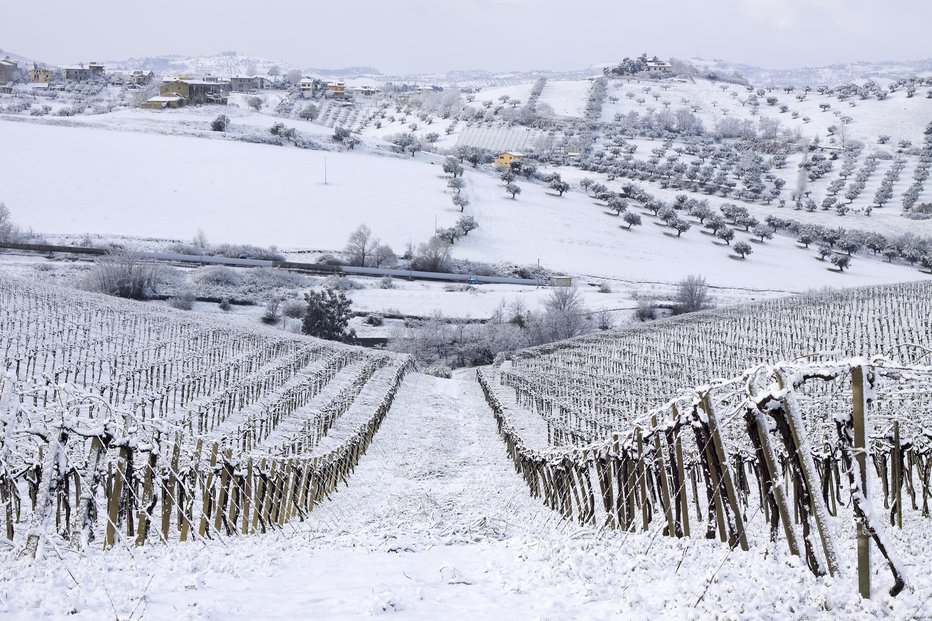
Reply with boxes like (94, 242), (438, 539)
(0, 372), (932, 620)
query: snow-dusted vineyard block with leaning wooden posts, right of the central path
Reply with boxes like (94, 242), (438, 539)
(479, 283), (932, 594)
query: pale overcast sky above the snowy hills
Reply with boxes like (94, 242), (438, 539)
(0, 0), (932, 74)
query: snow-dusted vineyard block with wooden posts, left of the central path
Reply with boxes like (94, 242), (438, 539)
(0, 279), (409, 555)
